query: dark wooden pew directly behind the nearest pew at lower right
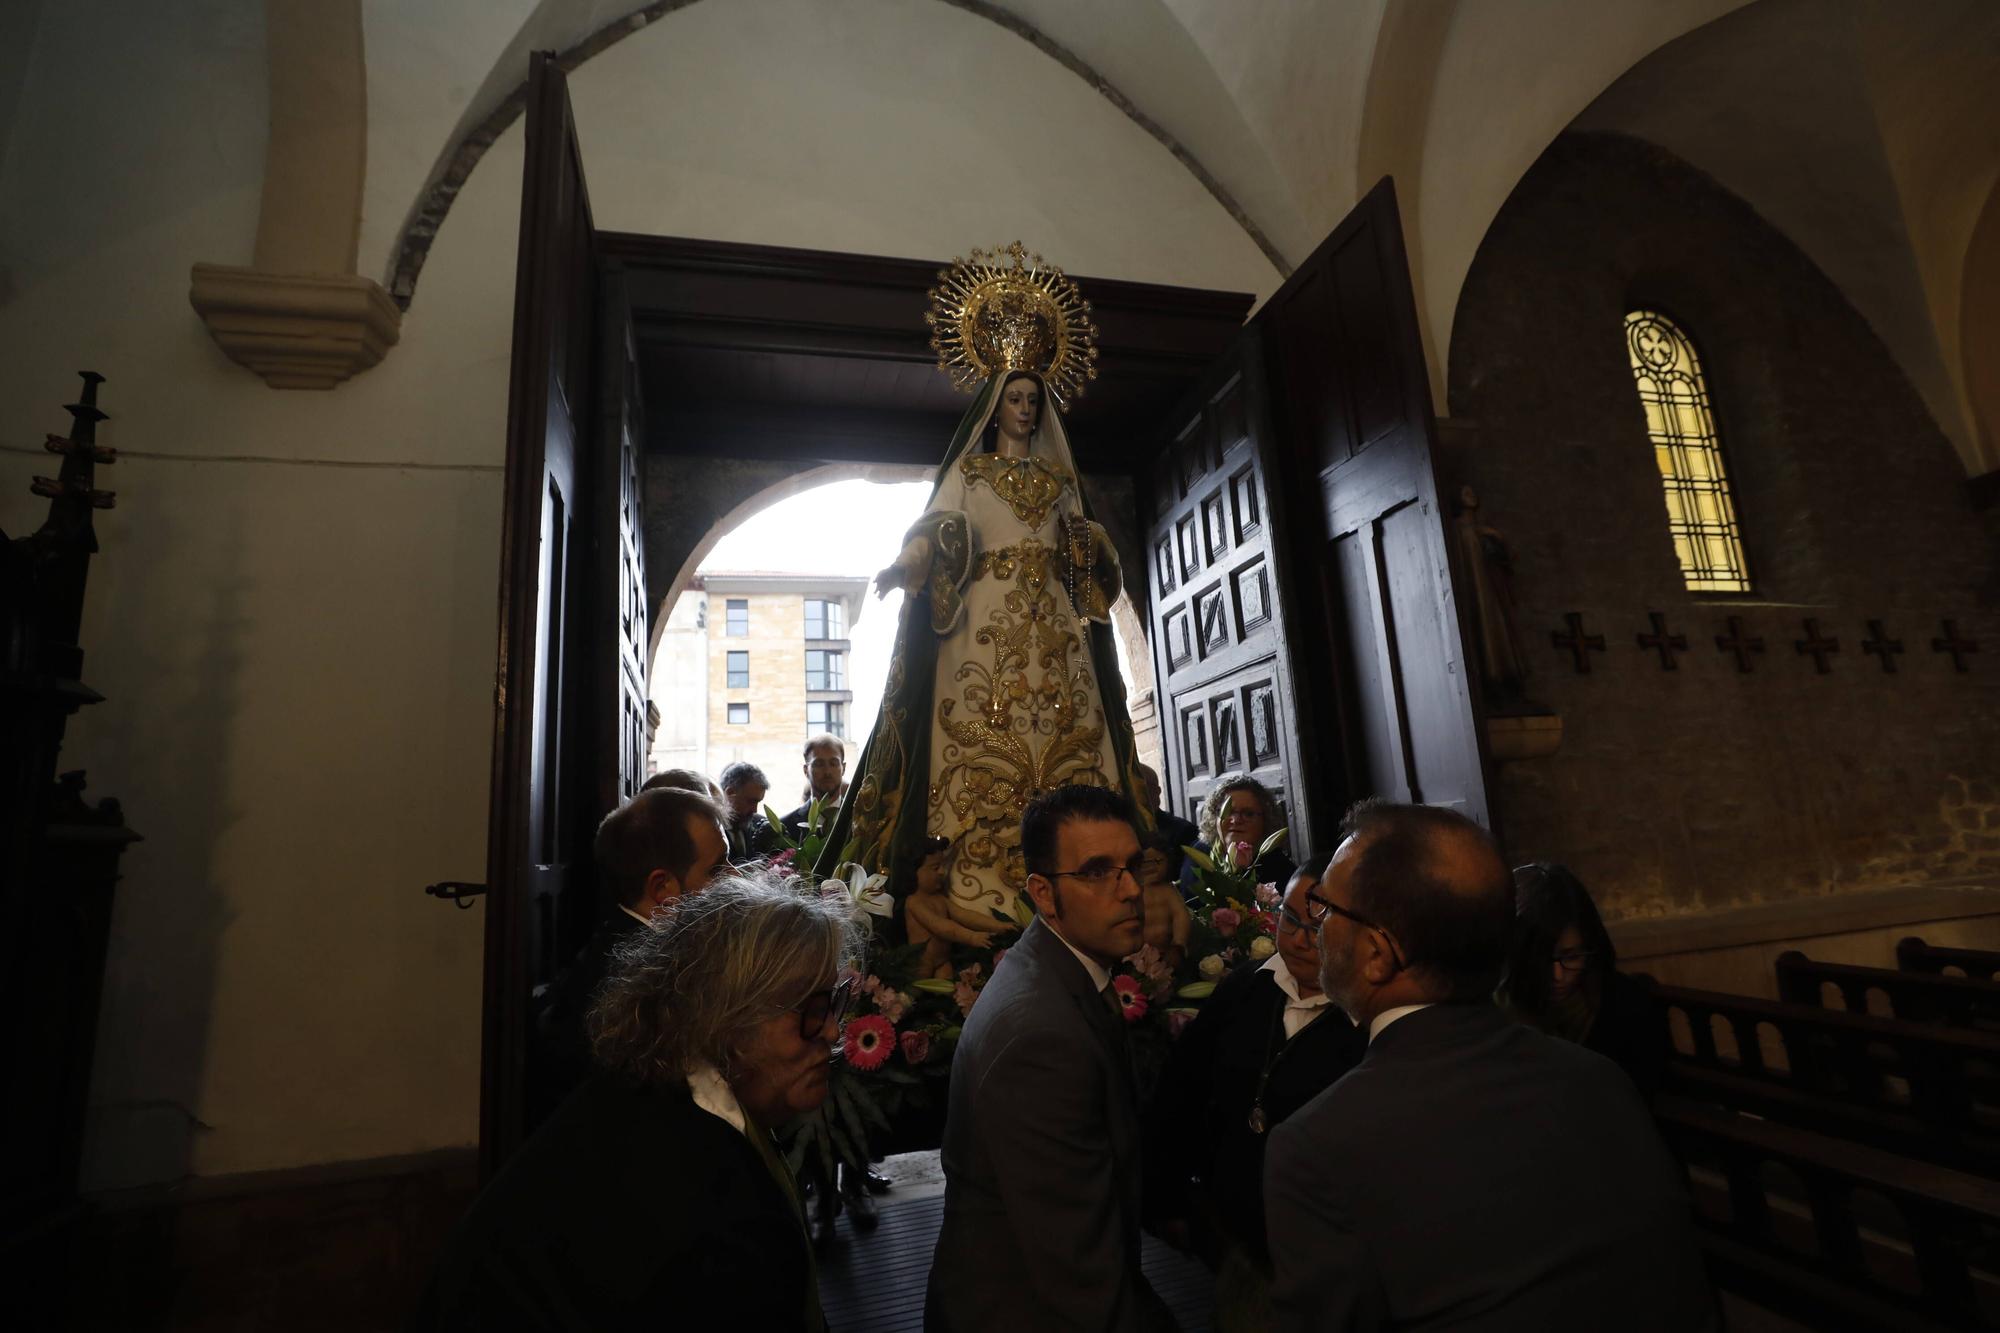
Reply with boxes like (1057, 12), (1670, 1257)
(1654, 985), (2000, 1173)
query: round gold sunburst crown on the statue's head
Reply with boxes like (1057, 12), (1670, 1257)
(924, 240), (1098, 408)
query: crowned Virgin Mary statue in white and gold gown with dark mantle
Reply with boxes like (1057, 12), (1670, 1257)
(818, 242), (1144, 933)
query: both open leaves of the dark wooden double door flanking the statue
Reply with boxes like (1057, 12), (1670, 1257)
(480, 56), (1488, 1171)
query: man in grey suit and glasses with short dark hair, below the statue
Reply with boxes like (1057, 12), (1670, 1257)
(924, 787), (1174, 1333)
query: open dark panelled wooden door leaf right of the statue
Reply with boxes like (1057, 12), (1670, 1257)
(1148, 180), (1490, 857)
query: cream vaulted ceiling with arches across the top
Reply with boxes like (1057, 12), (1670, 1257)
(344, 0), (2000, 472)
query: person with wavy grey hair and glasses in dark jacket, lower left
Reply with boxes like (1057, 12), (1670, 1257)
(412, 873), (858, 1333)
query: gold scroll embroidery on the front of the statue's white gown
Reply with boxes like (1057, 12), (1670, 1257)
(930, 536), (1114, 907)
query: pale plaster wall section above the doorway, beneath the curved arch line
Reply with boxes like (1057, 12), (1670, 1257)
(564, 0), (1278, 290)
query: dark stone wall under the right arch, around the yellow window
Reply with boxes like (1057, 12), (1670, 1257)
(1440, 134), (2000, 917)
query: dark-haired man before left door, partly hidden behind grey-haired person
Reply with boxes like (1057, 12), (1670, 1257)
(532, 787), (728, 1119)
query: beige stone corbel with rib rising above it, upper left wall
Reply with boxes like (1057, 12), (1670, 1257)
(188, 0), (402, 388)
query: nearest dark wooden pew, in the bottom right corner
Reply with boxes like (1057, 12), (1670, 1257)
(1658, 1097), (2000, 1333)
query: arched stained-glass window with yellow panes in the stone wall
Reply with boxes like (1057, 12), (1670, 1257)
(1626, 310), (1750, 592)
